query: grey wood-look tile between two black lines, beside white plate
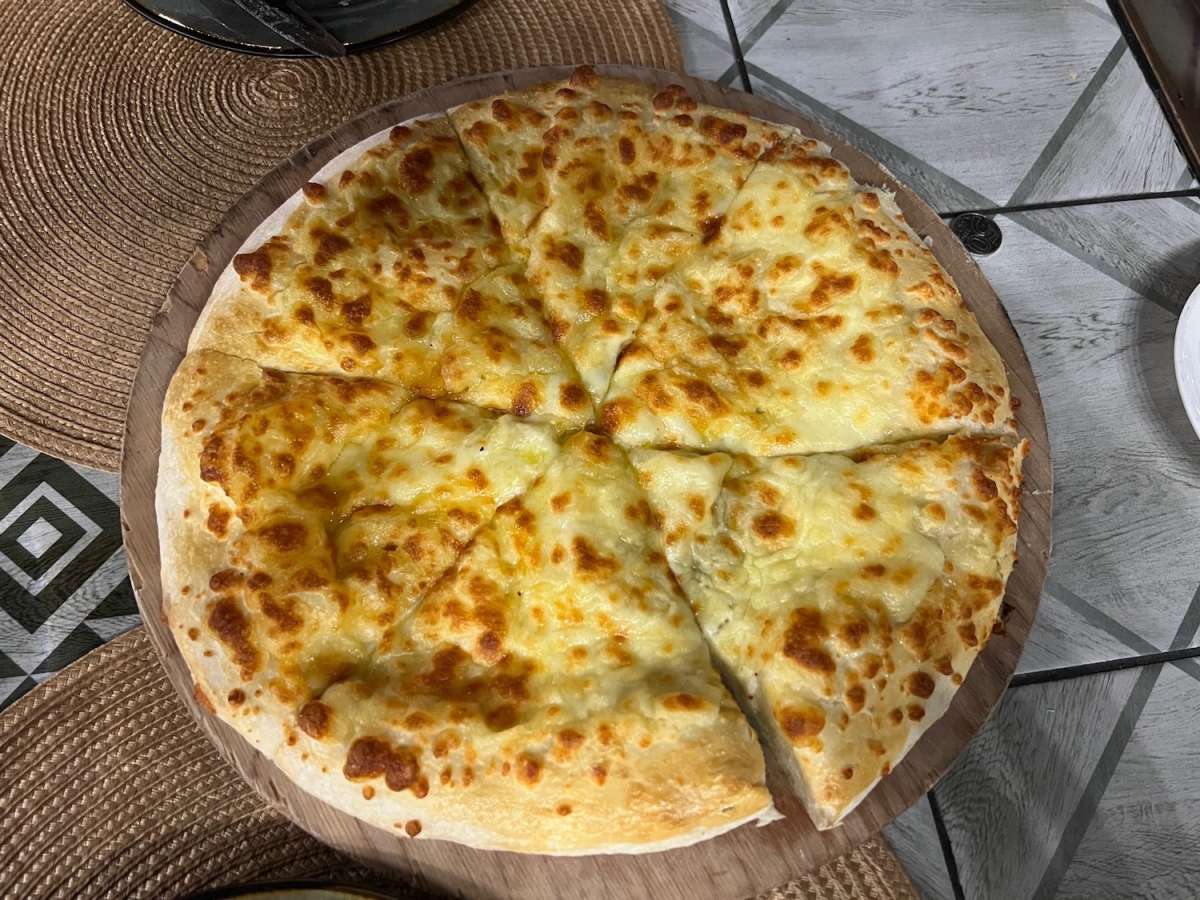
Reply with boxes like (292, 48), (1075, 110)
(980, 206), (1200, 665)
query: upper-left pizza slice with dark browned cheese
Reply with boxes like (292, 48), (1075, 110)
(191, 116), (590, 426)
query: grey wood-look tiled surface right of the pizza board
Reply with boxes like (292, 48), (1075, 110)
(668, 0), (1200, 900)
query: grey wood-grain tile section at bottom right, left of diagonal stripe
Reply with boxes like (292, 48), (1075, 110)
(935, 670), (1142, 900)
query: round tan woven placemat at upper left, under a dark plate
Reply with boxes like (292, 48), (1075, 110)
(0, 0), (682, 470)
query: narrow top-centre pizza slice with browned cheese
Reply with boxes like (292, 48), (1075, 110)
(450, 67), (781, 400)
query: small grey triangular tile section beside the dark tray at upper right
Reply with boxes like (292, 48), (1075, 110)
(1010, 47), (1187, 203)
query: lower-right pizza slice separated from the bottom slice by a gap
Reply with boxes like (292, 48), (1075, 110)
(632, 436), (1025, 828)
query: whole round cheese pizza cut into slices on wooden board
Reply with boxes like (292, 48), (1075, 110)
(157, 68), (1025, 854)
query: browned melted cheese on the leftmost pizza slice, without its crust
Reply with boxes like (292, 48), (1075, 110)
(178, 353), (557, 697)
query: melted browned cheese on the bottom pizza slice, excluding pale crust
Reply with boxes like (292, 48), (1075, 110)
(309, 434), (761, 854)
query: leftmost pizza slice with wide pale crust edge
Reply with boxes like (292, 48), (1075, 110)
(157, 350), (558, 750)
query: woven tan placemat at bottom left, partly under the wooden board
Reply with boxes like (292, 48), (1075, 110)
(0, 628), (917, 900)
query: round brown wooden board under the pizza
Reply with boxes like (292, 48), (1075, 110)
(121, 66), (1051, 900)
